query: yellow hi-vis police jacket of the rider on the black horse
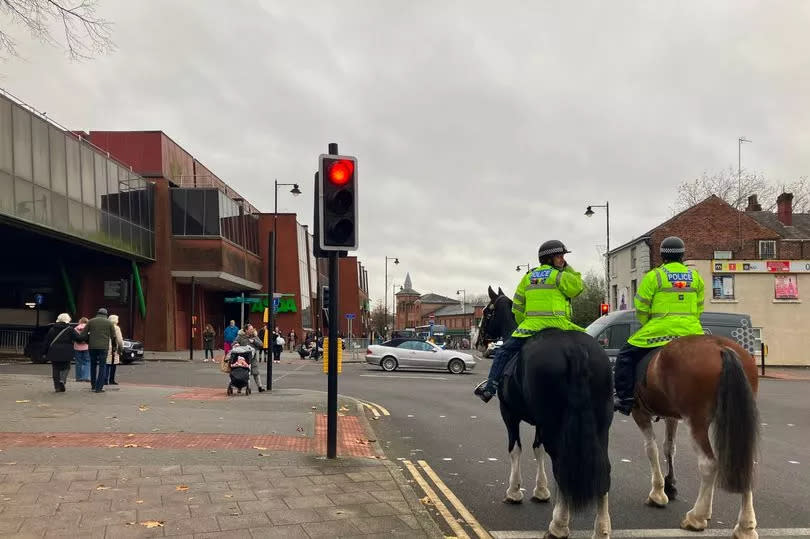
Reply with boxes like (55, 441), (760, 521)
(512, 264), (585, 338)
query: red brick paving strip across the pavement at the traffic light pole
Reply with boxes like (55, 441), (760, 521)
(0, 415), (376, 457)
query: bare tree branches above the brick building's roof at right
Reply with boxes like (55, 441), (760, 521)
(672, 168), (810, 213)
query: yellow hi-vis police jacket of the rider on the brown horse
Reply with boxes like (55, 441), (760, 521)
(627, 262), (704, 348)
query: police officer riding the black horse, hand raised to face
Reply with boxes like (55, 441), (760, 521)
(474, 240), (584, 402)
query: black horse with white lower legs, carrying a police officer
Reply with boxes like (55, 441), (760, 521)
(477, 287), (613, 538)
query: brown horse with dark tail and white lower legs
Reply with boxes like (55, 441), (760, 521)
(632, 335), (759, 539)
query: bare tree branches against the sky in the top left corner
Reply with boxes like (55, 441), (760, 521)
(0, 0), (115, 60)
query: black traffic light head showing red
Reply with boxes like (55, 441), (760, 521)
(318, 154), (357, 251)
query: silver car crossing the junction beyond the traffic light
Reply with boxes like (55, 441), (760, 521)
(366, 339), (475, 374)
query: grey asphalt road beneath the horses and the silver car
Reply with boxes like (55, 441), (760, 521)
(0, 354), (810, 537)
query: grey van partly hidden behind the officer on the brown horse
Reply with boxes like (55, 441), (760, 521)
(585, 310), (761, 364)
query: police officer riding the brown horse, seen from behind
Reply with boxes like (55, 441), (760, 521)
(614, 236), (703, 415)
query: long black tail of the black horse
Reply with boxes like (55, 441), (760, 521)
(554, 345), (607, 510)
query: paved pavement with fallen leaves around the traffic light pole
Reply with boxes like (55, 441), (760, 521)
(0, 374), (442, 539)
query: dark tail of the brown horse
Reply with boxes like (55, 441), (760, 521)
(714, 347), (759, 493)
